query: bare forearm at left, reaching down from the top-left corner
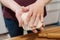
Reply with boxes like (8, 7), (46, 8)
(0, 0), (21, 12)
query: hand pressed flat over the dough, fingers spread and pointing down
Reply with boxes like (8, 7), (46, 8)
(26, 1), (44, 33)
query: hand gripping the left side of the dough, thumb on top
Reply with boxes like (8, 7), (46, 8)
(15, 7), (28, 27)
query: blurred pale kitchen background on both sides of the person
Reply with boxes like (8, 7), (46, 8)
(0, 0), (60, 40)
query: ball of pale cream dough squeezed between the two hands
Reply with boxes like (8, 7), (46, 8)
(21, 13), (42, 30)
